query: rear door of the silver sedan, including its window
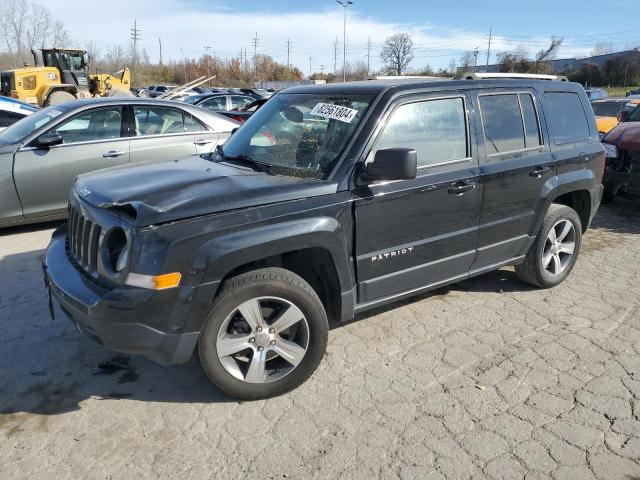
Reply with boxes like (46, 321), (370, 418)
(131, 105), (209, 163)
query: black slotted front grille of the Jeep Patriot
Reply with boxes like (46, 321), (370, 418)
(68, 207), (102, 275)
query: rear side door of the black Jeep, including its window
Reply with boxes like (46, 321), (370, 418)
(472, 88), (556, 272)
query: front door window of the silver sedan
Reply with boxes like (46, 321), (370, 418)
(50, 107), (122, 143)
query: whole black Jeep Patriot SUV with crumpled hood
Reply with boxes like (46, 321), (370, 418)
(43, 76), (604, 399)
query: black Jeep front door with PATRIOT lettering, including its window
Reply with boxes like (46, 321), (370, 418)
(354, 94), (482, 305)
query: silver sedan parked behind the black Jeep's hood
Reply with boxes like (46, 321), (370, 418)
(0, 98), (239, 228)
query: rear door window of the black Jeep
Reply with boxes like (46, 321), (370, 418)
(479, 93), (542, 155)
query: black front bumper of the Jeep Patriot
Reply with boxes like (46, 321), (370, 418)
(43, 225), (217, 364)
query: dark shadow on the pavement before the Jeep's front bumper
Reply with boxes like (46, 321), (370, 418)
(0, 246), (235, 422)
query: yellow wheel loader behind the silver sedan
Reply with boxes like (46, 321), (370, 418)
(0, 48), (132, 107)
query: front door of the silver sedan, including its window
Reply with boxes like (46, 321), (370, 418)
(13, 106), (129, 218)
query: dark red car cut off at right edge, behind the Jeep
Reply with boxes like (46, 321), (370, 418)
(602, 105), (640, 200)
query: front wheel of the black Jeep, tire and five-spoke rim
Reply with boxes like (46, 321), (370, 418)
(198, 268), (329, 400)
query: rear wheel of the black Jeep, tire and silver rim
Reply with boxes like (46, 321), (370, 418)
(516, 203), (582, 288)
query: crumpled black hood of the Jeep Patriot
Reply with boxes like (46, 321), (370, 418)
(74, 156), (337, 226)
